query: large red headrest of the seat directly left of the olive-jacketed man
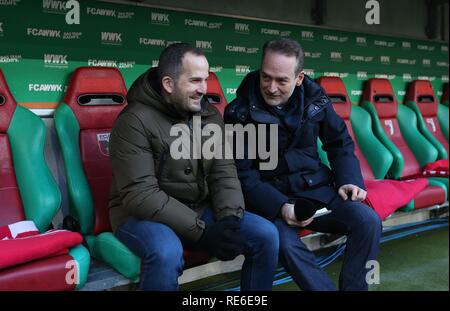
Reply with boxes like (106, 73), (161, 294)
(64, 67), (127, 129)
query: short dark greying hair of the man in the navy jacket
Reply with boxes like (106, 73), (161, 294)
(262, 38), (305, 74)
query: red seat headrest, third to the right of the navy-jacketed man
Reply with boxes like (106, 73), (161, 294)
(405, 80), (438, 117)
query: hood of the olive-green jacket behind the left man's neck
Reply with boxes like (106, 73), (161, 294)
(127, 68), (214, 119)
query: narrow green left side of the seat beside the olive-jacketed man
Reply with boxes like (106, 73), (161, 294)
(54, 103), (95, 235)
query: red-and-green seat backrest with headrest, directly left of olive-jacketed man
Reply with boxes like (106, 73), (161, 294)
(54, 67), (127, 234)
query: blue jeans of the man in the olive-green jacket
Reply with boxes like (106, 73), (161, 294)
(115, 209), (279, 291)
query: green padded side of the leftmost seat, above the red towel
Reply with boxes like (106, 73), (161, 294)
(7, 106), (61, 232)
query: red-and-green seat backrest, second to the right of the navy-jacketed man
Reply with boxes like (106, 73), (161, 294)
(362, 79), (437, 178)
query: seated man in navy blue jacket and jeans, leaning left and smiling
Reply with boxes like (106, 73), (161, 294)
(225, 39), (382, 290)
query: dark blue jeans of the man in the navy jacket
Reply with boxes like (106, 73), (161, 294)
(275, 197), (382, 291)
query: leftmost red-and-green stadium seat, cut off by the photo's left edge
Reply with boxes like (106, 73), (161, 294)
(0, 70), (90, 291)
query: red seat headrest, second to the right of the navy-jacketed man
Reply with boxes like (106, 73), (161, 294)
(362, 78), (398, 118)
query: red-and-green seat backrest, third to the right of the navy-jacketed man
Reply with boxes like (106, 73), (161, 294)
(405, 80), (448, 158)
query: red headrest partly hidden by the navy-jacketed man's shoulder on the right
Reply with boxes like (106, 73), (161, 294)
(316, 77), (352, 120)
